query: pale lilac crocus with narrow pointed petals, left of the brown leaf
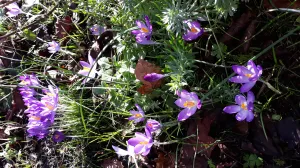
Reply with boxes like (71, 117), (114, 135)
(78, 54), (97, 83)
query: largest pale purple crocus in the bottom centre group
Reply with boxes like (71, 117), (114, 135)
(128, 129), (153, 156)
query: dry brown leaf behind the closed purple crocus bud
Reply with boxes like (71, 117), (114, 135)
(134, 59), (162, 94)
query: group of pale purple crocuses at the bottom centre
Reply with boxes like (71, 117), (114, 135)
(112, 104), (162, 157)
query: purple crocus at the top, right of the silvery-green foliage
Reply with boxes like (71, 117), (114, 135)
(183, 21), (204, 41)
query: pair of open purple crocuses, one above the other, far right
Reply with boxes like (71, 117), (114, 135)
(223, 60), (262, 122)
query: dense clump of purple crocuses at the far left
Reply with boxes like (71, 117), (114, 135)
(19, 74), (58, 139)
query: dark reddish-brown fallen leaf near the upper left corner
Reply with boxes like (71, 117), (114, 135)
(55, 16), (73, 39)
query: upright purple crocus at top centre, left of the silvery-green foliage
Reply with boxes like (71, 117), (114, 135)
(131, 16), (158, 45)
